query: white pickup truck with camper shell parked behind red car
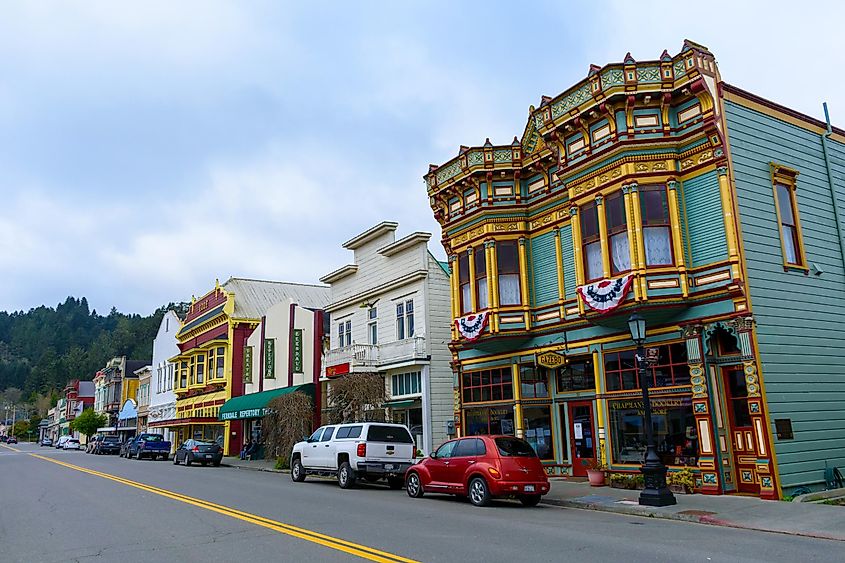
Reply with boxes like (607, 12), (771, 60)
(290, 422), (416, 489)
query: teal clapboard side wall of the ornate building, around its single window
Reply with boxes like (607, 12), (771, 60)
(725, 102), (845, 489)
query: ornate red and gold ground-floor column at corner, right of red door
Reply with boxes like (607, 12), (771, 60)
(729, 316), (778, 500)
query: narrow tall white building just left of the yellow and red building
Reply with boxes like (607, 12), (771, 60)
(147, 311), (181, 447)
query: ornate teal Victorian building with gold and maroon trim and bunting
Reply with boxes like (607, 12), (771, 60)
(425, 41), (845, 498)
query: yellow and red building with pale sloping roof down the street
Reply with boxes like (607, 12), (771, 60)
(169, 278), (325, 455)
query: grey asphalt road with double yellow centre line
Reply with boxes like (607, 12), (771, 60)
(0, 444), (845, 563)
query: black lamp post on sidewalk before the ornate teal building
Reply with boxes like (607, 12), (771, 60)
(628, 313), (677, 506)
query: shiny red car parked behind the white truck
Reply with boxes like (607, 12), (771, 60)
(405, 436), (549, 506)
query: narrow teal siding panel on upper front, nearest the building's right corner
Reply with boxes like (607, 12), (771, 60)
(683, 170), (728, 267)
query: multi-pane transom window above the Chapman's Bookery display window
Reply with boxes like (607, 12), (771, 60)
(604, 342), (689, 391)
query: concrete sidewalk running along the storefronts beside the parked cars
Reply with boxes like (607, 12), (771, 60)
(223, 457), (845, 541)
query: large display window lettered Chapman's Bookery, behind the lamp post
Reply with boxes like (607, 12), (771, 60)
(608, 397), (698, 466)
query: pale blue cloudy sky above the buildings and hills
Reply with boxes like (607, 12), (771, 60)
(0, 0), (845, 314)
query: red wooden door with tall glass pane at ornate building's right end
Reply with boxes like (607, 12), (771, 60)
(722, 367), (760, 494)
